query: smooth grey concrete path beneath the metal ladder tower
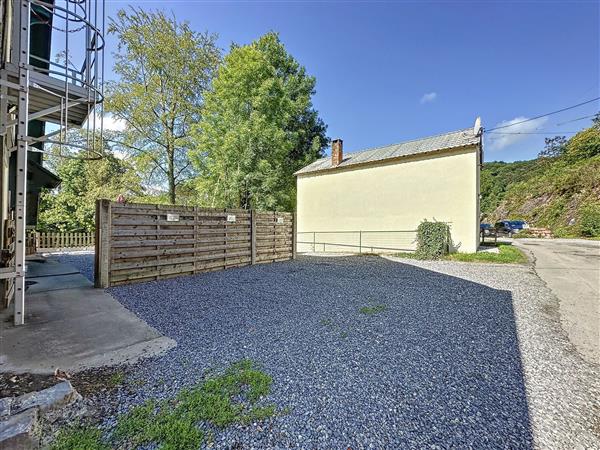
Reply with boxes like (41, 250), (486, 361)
(0, 258), (175, 373)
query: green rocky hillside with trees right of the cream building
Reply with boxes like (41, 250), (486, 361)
(481, 116), (600, 237)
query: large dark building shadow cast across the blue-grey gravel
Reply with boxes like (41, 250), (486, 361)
(109, 257), (533, 448)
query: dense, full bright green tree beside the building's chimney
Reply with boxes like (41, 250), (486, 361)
(192, 33), (328, 209)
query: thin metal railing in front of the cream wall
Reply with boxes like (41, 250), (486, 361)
(297, 230), (417, 253)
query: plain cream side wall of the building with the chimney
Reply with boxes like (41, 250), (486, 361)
(297, 146), (479, 252)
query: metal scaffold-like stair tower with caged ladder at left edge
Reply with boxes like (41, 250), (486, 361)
(0, 0), (105, 325)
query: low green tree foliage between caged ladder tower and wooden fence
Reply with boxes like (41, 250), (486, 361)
(38, 149), (143, 231)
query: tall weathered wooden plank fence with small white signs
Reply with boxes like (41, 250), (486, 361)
(95, 200), (296, 287)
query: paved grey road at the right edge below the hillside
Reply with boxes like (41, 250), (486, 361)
(515, 239), (600, 363)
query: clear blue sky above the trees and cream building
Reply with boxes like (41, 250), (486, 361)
(101, 0), (600, 161)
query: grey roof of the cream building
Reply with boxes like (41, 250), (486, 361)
(295, 127), (479, 175)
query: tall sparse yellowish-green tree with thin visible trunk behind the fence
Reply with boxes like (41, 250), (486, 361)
(106, 8), (221, 203)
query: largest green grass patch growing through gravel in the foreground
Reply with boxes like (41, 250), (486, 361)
(52, 359), (277, 450)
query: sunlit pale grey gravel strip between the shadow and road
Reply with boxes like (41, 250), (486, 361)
(390, 258), (600, 449)
